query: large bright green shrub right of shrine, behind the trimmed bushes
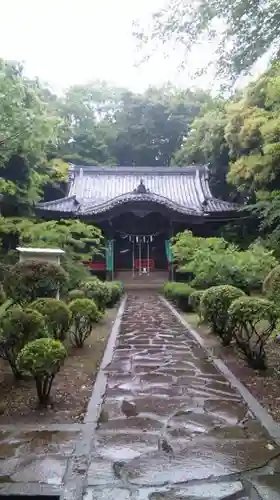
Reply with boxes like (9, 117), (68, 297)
(172, 231), (277, 292)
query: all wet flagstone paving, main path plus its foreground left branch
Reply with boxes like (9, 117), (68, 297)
(0, 294), (280, 500)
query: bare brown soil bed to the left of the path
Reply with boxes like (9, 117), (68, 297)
(0, 308), (118, 425)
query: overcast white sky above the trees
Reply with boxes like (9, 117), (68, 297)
(0, 0), (219, 91)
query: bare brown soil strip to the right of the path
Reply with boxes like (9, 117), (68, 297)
(182, 313), (280, 422)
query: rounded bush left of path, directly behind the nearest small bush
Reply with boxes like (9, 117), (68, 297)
(30, 297), (71, 342)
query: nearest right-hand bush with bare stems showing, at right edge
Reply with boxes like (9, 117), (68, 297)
(228, 297), (277, 369)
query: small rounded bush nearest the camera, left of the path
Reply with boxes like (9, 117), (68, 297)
(16, 338), (66, 405)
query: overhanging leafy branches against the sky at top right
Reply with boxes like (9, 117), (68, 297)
(137, 0), (280, 81)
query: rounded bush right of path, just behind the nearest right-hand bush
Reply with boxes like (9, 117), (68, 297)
(200, 285), (245, 345)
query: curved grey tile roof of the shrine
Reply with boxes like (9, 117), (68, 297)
(37, 166), (236, 215)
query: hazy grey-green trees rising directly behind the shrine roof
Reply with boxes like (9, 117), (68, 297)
(58, 82), (209, 166)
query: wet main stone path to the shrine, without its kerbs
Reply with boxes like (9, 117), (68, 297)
(84, 295), (280, 500)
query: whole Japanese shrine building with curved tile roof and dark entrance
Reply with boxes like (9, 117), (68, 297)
(37, 166), (237, 278)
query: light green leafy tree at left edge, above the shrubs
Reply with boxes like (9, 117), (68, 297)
(0, 60), (60, 215)
